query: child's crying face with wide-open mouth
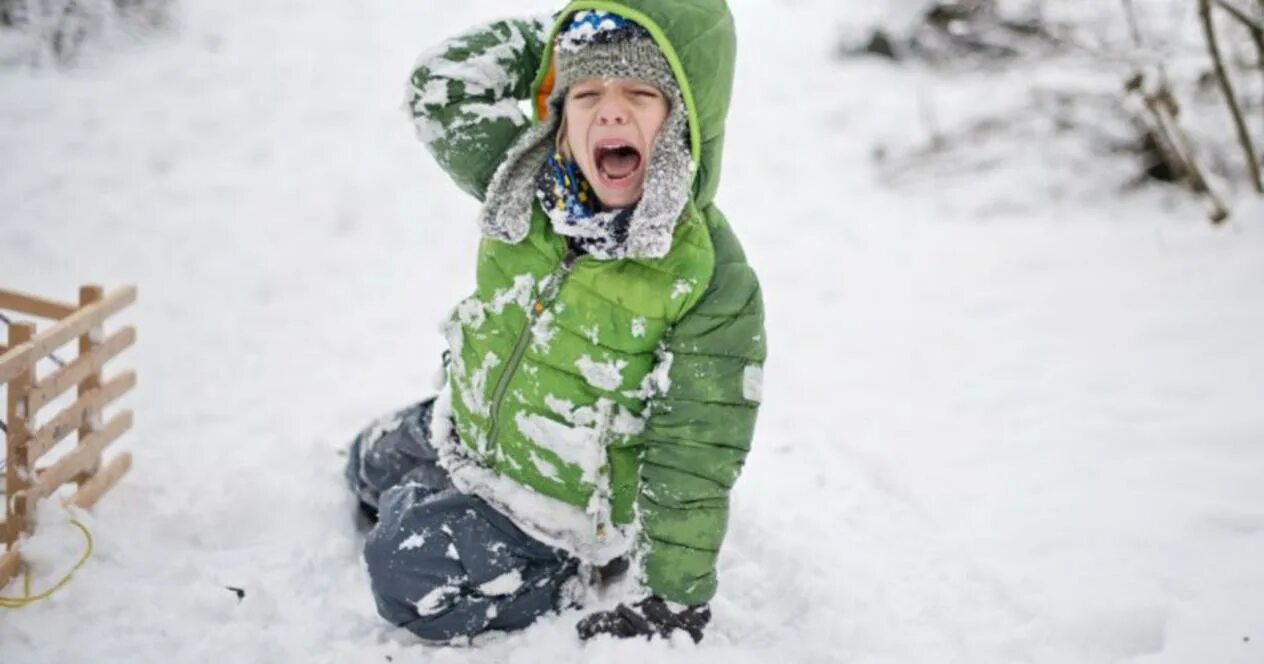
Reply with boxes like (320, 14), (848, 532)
(562, 78), (667, 207)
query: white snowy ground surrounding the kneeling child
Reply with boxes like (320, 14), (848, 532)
(0, 0), (1264, 664)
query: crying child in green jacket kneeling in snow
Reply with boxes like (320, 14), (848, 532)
(346, 0), (765, 641)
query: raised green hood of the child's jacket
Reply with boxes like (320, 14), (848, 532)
(532, 0), (737, 207)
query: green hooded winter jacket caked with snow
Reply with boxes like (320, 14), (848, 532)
(408, 0), (765, 605)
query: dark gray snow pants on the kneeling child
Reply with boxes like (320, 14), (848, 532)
(346, 400), (578, 641)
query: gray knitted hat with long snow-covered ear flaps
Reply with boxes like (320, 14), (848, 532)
(479, 10), (693, 258)
